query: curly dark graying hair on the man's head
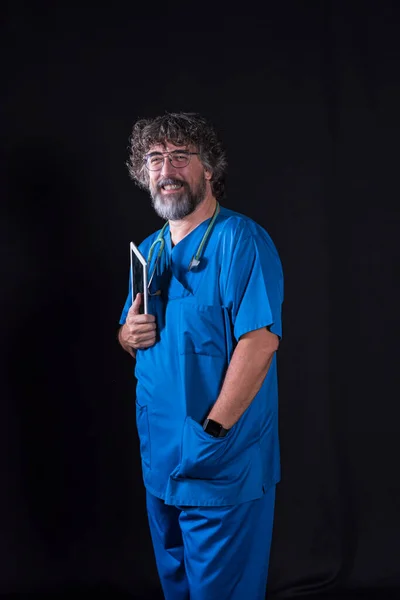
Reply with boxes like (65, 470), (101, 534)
(126, 112), (227, 200)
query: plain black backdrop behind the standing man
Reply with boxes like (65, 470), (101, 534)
(0, 1), (400, 598)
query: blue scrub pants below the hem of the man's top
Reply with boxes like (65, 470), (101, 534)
(147, 486), (275, 600)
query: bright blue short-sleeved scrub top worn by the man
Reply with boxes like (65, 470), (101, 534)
(120, 207), (283, 506)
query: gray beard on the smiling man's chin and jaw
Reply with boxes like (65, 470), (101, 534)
(151, 175), (206, 221)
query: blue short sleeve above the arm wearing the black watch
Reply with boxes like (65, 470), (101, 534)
(221, 228), (283, 341)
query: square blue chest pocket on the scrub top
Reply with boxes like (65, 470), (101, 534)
(178, 301), (226, 357)
